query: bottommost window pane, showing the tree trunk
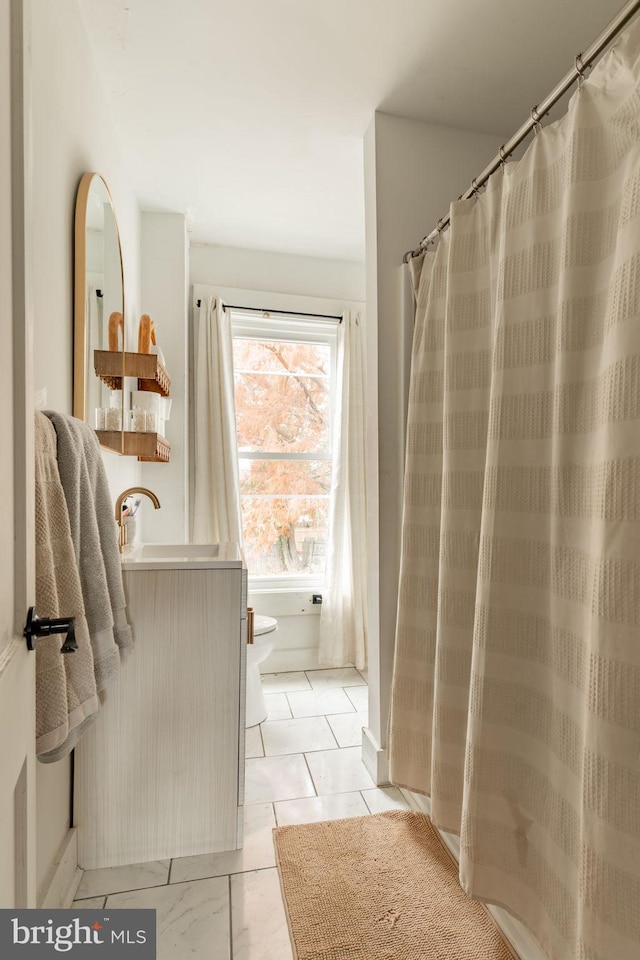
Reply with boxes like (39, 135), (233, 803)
(241, 496), (329, 577)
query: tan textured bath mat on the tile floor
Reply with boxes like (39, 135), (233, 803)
(273, 810), (515, 960)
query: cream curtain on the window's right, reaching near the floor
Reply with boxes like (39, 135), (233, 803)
(318, 311), (367, 669)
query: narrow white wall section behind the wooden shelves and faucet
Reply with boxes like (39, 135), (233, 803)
(140, 213), (189, 543)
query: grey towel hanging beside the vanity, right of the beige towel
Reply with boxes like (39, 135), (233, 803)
(45, 410), (132, 691)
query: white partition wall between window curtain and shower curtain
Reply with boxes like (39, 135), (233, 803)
(363, 113), (503, 781)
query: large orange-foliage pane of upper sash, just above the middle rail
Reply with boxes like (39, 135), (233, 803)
(235, 373), (330, 453)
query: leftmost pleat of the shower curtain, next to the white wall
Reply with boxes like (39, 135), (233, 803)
(389, 248), (449, 795)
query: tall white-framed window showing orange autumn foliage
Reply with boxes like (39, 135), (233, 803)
(231, 308), (336, 585)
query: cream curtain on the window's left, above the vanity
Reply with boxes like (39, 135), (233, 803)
(191, 297), (243, 546)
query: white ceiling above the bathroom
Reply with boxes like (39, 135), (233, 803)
(78, 0), (623, 261)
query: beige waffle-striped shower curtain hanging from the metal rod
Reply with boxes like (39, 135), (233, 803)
(390, 18), (640, 960)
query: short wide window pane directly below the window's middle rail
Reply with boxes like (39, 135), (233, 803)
(239, 459), (331, 497)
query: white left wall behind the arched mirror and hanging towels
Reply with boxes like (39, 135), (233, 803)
(30, 0), (139, 889)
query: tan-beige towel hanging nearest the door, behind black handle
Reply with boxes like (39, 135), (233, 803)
(35, 411), (100, 763)
